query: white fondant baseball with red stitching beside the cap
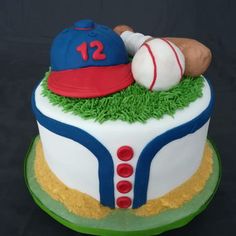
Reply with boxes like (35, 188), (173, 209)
(131, 38), (185, 91)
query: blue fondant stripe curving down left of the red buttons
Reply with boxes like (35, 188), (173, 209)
(31, 87), (115, 208)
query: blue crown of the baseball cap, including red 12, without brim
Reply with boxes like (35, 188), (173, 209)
(51, 20), (128, 71)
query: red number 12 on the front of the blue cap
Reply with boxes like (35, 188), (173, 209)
(76, 40), (106, 61)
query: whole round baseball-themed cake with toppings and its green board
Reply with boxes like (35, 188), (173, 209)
(26, 20), (219, 235)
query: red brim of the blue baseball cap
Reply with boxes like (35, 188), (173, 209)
(48, 63), (134, 98)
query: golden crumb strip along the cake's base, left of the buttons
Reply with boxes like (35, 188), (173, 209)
(34, 141), (111, 219)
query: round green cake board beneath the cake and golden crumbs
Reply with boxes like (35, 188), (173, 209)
(24, 137), (221, 236)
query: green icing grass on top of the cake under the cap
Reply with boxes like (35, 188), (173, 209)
(42, 72), (204, 123)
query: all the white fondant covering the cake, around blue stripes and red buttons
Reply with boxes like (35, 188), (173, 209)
(35, 80), (211, 206)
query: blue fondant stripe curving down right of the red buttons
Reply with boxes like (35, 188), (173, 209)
(133, 79), (214, 208)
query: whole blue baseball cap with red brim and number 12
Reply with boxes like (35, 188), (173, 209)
(48, 20), (134, 98)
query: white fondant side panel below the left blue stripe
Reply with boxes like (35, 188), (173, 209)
(38, 123), (100, 201)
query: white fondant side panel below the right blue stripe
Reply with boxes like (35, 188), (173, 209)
(147, 121), (209, 200)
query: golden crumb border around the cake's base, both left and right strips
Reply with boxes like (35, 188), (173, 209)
(34, 140), (213, 219)
